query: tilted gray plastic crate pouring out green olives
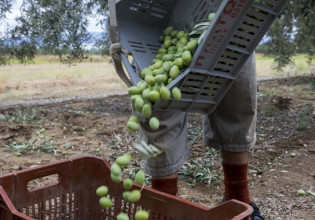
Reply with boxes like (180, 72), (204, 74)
(111, 0), (287, 113)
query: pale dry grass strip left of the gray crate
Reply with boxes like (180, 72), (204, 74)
(0, 58), (126, 101)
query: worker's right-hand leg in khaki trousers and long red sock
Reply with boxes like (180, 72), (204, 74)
(204, 52), (257, 203)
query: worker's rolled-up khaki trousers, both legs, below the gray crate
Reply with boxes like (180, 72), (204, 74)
(141, 54), (257, 176)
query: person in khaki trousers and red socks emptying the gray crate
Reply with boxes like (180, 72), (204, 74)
(141, 53), (263, 220)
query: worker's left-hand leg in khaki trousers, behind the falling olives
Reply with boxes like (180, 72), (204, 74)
(141, 111), (189, 195)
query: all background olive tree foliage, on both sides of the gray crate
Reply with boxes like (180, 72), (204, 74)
(0, 0), (315, 70)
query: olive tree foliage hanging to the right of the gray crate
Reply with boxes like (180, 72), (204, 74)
(266, 0), (315, 71)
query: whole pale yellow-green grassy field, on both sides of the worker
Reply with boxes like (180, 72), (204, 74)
(0, 54), (314, 102)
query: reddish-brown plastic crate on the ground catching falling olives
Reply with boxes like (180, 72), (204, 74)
(0, 157), (253, 220)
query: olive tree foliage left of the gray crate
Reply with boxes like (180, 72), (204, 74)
(0, 0), (108, 64)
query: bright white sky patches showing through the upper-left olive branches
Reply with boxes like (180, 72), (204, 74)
(0, 0), (102, 32)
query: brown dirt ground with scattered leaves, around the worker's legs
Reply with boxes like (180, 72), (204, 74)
(0, 77), (315, 220)
